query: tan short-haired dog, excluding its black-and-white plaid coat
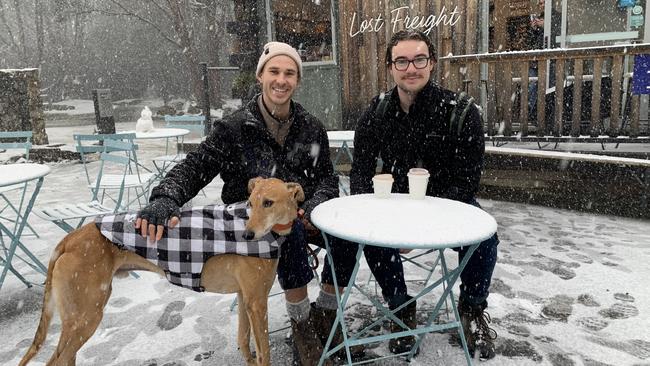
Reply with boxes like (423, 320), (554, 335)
(20, 178), (305, 366)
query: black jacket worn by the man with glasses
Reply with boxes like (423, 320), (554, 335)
(350, 82), (485, 203)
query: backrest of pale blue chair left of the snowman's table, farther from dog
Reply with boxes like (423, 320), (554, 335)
(73, 133), (138, 184)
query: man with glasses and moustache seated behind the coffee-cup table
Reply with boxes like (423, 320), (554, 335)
(334, 31), (499, 359)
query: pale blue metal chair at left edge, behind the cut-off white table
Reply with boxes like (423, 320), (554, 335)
(0, 131), (39, 239)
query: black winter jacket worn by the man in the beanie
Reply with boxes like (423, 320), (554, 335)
(150, 96), (339, 219)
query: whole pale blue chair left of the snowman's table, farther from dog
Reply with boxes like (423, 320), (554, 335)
(74, 133), (156, 210)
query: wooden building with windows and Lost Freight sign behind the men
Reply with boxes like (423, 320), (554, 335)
(216, 0), (648, 135)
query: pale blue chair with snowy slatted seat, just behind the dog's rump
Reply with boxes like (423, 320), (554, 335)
(33, 138), (140, 233)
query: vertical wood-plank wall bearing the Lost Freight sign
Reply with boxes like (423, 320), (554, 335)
(338, 0), (478, 128)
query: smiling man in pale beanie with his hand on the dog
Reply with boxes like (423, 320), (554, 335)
(136, 42), (339, 366)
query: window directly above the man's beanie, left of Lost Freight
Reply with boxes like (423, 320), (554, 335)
(269, 0), (335, 62)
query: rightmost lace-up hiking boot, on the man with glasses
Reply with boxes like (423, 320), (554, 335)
(458, 298), (497, 360)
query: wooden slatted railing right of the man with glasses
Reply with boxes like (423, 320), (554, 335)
(439, 43), (650, 142)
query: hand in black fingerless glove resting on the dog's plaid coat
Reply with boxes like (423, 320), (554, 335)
(135, 197), (181, 241)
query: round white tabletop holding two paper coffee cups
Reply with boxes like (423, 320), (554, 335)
(311, 194), (497, 249)
